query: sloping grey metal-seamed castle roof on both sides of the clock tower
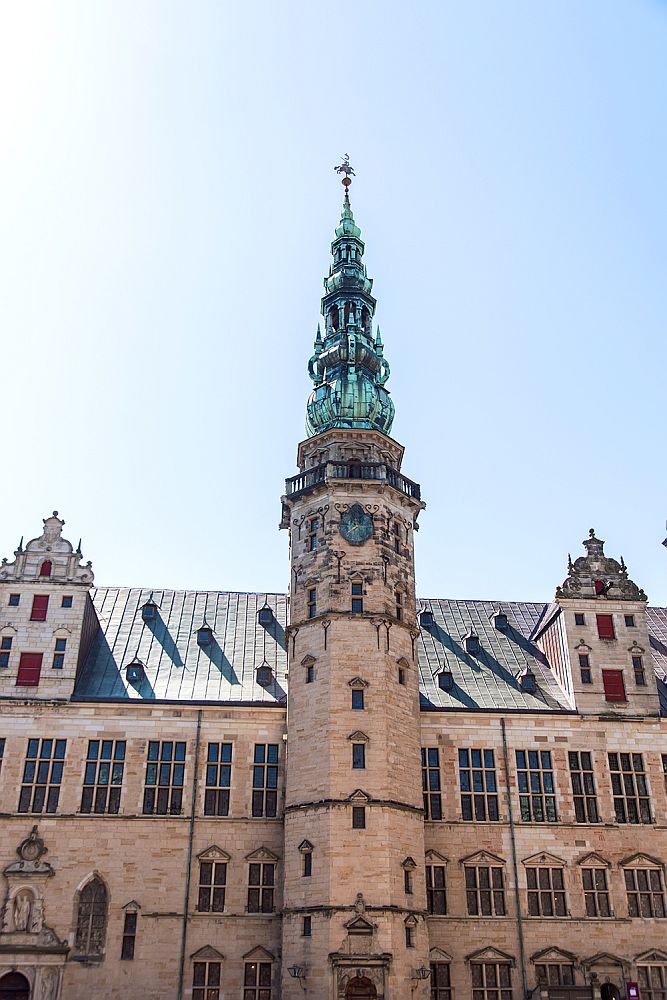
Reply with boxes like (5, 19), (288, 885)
(74, 587), (667, 715)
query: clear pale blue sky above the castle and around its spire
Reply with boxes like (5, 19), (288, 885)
(0, 0), (667, 604)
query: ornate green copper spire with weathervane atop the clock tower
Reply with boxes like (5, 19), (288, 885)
(306, 155), (394, 437)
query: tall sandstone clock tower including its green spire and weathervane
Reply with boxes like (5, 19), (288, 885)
(282, 162), (428, 1000)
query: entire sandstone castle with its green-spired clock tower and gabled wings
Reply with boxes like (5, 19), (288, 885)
(0, 172), (667, 1000)
